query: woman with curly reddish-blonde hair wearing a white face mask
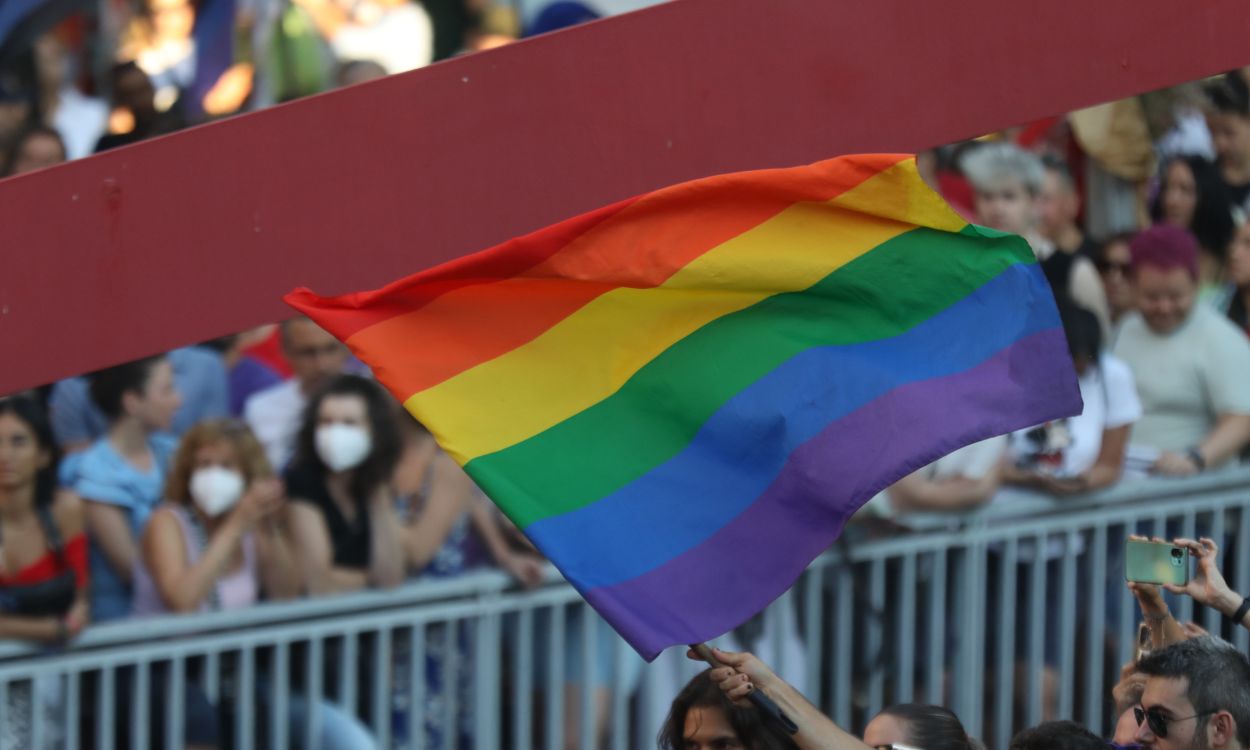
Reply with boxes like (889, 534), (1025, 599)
(134, 420), (374, 748)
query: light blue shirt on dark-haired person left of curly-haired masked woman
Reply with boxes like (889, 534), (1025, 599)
(61, 435), (178, 623)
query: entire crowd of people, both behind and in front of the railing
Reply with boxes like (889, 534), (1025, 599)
(0, 0), (1250, 750)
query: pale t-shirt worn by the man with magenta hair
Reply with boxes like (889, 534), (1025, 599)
(1115, 304), (1250, 453)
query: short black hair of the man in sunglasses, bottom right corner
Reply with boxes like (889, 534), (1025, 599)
(1138, 635), (1250, 748)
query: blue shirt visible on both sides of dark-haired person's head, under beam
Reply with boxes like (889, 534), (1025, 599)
(49, 346), (230, 445)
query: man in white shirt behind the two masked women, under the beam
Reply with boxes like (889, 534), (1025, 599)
(243, 318), (350, 471)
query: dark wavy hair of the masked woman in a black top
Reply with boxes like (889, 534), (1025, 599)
(294, 375), (403, 504)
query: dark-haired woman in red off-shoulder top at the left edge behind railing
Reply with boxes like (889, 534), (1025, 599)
(0, 396), (88, 748)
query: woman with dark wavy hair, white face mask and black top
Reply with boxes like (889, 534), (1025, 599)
(285, 375), (404, 594)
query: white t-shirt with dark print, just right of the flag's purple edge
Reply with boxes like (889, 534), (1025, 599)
(1010, 355), (1141, 478)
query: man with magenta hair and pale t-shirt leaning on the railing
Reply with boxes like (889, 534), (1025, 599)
(1115, 225), (1250, 476)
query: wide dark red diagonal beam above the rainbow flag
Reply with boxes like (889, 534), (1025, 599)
(0, 0), (1250, 394)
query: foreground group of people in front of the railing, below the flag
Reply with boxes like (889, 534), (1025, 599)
(659, 539), (1250, 750)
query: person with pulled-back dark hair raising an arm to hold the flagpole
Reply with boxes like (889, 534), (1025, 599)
(695, 649), (981, 750)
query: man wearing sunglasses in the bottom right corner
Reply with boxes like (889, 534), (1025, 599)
(1134, 636), (1250, 750)
